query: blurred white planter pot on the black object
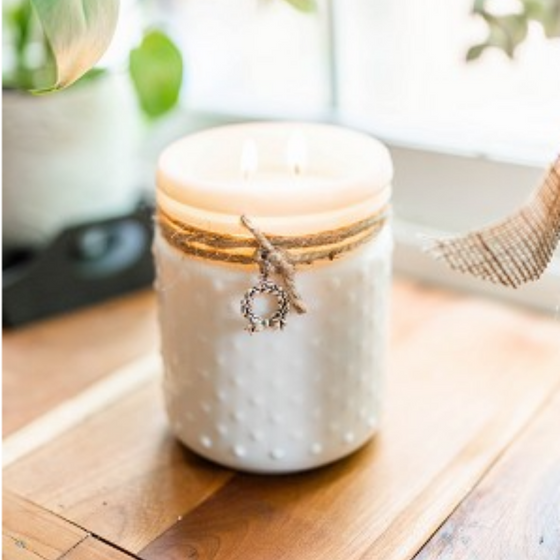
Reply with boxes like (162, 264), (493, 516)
(3, 76), (139, 247)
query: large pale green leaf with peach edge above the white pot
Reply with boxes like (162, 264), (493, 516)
(31, 0), (119, 93)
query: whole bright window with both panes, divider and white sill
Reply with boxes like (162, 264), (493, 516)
(158, 0), (560, 310)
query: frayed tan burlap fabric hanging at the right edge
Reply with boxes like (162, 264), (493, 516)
(426, 157), (560, 288)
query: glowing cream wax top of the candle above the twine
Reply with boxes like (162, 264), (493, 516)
(157, 122), (393, 233)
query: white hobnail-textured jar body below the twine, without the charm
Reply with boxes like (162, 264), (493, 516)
(154, 122), (392, 473)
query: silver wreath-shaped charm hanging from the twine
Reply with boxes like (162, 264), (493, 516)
(241, 275), (290, 334)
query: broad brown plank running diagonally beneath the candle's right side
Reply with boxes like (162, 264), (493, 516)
(140, 294), (560, 560)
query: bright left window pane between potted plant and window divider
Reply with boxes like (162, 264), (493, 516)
(174, 0), (328, 117)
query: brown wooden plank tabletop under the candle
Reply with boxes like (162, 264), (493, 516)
(3, 280), (560, 560)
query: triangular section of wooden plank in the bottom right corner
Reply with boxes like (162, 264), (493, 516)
(416, 384), (560, 560)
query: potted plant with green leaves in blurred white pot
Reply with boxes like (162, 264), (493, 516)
(3, 0), (183, 248)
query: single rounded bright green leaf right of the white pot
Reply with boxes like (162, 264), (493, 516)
(130, 31), (183, 117)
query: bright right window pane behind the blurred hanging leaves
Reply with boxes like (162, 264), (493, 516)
(336, 0), (560, 162)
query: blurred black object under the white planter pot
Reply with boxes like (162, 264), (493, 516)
(2, 204), (154, 327)
